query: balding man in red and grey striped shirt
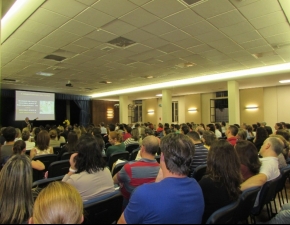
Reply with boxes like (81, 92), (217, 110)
(113, 136), (160, 208)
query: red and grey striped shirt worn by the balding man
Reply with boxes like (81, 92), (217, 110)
(117, 158), (160, 200)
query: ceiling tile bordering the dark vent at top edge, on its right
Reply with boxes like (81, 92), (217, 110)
(191, 0), (234, 19)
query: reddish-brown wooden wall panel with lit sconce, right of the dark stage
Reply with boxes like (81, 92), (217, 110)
(92, 100), (119, 125)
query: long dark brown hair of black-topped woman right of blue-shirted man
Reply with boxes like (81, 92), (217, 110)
(207, 140), (242, 199)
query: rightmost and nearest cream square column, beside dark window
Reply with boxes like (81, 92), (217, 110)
(228, 81), (240, 125)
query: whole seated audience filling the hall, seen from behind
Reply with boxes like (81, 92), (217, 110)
(0, 119), (290, 224)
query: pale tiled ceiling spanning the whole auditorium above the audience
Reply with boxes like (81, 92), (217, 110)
(1, 0), (290, 100)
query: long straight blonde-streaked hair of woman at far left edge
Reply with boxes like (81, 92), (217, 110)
(0, 154), (33, 224)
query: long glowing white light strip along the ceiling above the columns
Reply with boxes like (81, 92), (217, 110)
(92, 63), (290, 98)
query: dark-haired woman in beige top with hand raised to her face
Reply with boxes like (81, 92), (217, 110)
(62, 134), (115, 201)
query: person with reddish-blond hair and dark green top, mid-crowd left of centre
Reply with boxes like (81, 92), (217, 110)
(106, 131), (126, 159)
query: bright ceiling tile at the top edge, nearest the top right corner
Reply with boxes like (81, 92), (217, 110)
(239, 0), (281, 20)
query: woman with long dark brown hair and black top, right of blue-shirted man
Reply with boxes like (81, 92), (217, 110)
(199, 140), (242, 222)
